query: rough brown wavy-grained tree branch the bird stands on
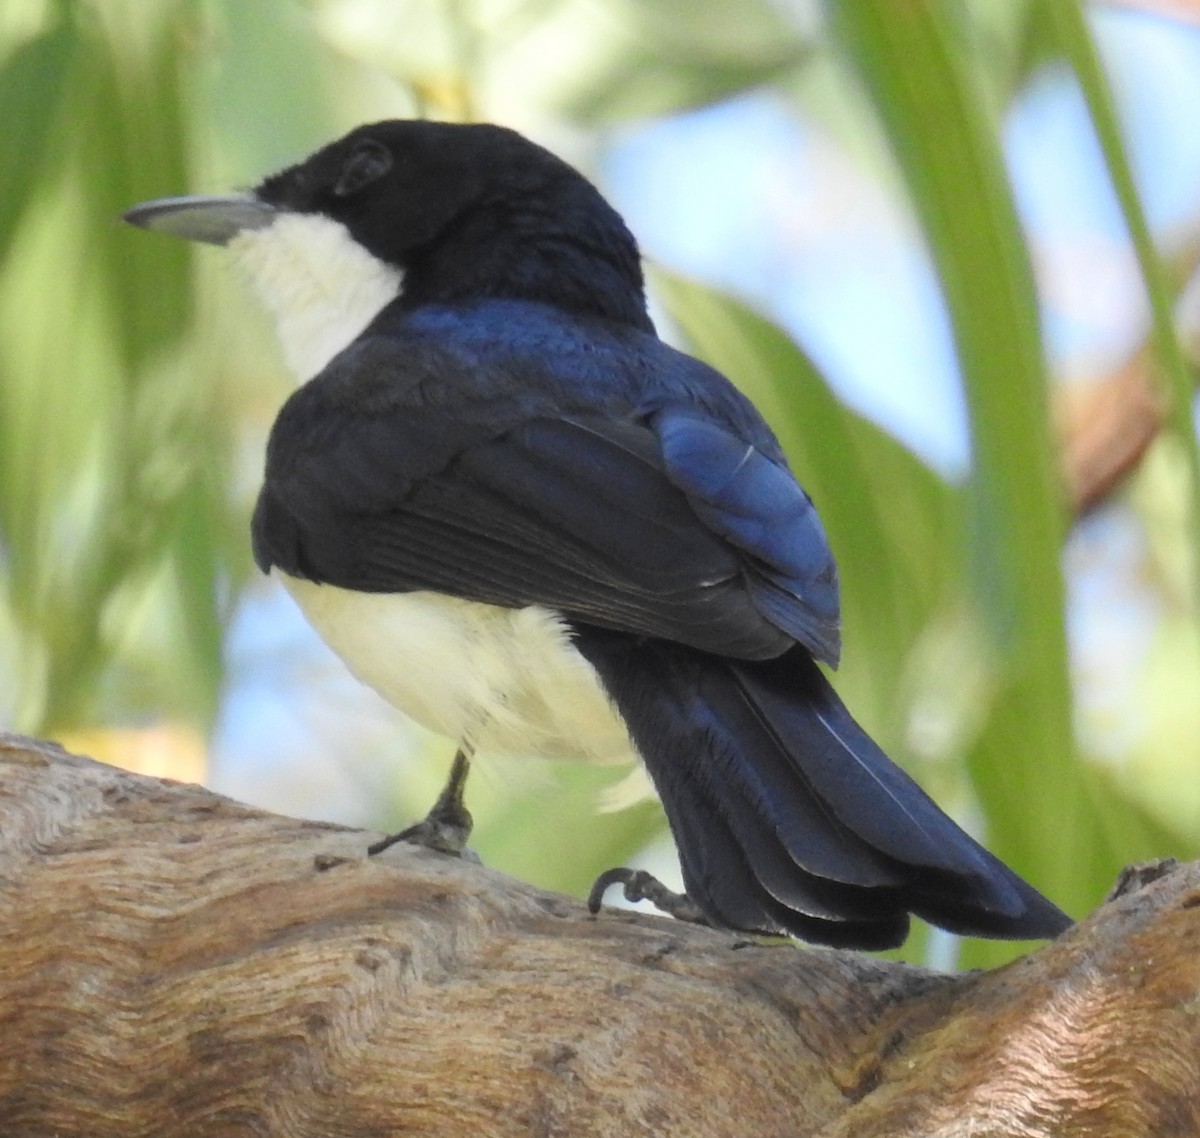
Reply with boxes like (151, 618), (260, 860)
(0, 736), (1200, 1138)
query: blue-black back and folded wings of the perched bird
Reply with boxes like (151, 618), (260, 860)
(254, 312), (838, 661)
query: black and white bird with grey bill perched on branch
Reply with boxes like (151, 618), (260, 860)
(125, 120), (1070, 950)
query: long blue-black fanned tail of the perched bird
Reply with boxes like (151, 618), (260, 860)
(576, 625), (1070, 948)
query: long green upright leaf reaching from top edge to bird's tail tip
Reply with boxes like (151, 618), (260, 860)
(830, 0), (1118, 965)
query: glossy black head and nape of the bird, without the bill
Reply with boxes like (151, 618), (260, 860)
(254, 120), (650, 330)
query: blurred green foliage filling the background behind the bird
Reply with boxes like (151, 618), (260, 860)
(0, 0), (1200, 964)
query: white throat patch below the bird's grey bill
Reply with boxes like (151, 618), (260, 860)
(226, 214), (403, 382)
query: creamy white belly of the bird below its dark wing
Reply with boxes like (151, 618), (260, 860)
(276, 570), (636, 762)
